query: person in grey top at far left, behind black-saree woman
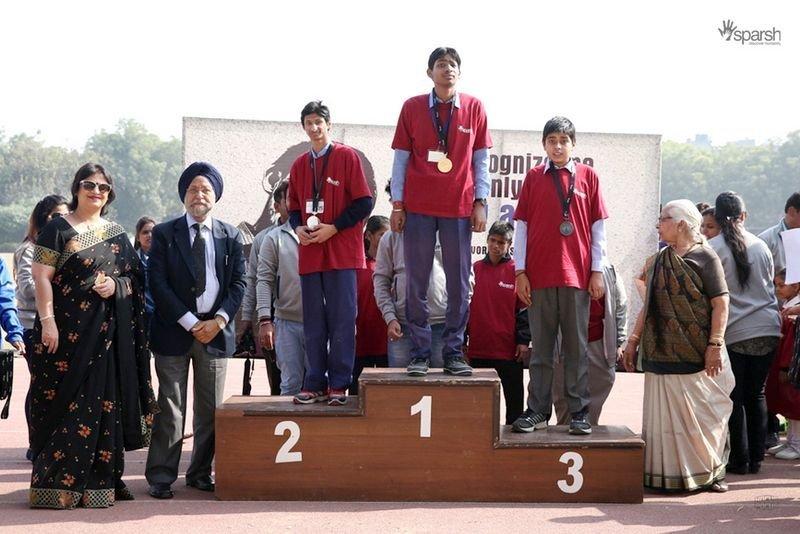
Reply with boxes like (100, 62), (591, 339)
(14, 195), (69, 461)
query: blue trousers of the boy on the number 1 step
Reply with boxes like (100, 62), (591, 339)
(403, 213), (472, 360)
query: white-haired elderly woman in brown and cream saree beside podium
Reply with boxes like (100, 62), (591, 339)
(623, 200), (734, 492)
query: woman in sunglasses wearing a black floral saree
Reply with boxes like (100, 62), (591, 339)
(30, 163), (158, 509)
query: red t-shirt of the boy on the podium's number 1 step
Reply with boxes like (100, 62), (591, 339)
(392, 93), (492, 217)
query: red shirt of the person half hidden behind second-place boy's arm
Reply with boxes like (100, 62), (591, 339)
(356, 258), (388, 358)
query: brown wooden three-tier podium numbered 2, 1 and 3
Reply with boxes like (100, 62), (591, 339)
(216, 369), (644, 503)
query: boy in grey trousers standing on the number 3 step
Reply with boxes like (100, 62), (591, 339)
(513, 117), (608, 434)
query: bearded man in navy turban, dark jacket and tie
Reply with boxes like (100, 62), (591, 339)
(145, 161), (245, 499)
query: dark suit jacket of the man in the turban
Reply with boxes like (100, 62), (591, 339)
(148, 215), (245, 356)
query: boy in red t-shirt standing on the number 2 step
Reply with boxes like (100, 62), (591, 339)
(289, 102), (372, 406)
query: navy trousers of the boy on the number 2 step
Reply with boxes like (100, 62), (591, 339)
(300, 269), (357, 392)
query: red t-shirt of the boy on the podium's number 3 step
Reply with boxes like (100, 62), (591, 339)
(514, 163), (608, 289)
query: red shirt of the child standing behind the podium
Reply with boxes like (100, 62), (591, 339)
(467, 258), (525, 360)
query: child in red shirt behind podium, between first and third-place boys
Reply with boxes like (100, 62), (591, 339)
(467, 221), (531, 425)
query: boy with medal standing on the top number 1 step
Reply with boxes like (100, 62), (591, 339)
(391, 47), (492, 382)
